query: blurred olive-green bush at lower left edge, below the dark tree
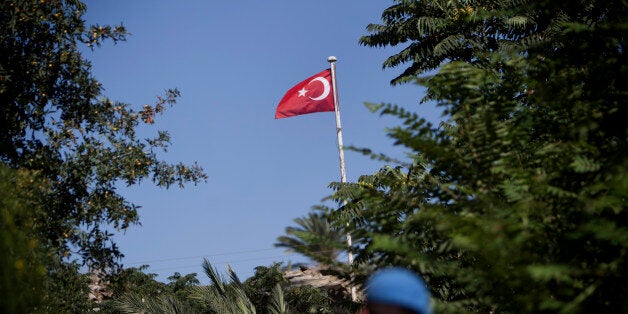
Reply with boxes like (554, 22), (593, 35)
(0, 164), (48, 313)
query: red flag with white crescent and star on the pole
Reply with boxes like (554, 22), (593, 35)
(275, 69), (334, 119)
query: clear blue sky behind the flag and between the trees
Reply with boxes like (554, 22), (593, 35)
(85, 0), (440, 282)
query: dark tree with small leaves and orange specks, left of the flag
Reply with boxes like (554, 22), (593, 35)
(0, 0), (206, 270)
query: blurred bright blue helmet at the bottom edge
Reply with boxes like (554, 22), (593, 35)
(366, 267), (432, 314)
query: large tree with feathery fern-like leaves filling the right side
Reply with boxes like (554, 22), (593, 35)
(333, 0), (628, 313)
